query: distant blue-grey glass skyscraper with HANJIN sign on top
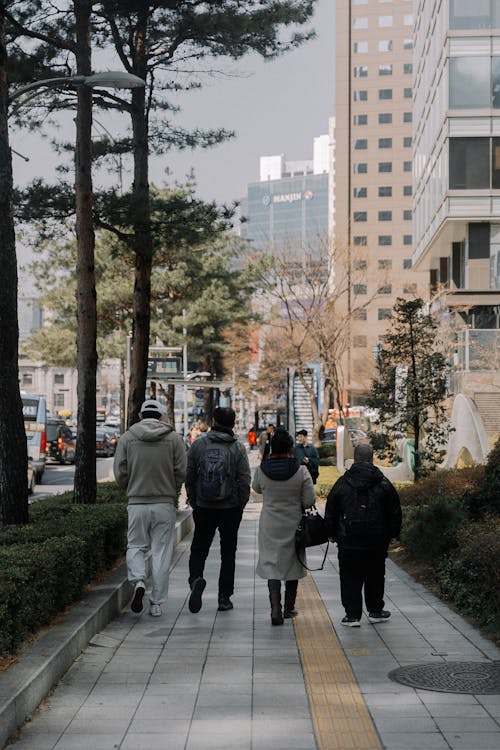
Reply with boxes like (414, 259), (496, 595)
(243, 135), (329, 258)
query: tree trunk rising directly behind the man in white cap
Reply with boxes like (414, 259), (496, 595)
(127, 19), (153, 427)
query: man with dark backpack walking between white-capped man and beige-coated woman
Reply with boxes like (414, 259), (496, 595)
(186, 406), (251, 612)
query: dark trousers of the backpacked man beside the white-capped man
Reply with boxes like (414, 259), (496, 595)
(189, 508), (243, 596)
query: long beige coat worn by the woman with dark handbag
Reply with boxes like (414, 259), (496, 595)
(252, 466), (316, 581)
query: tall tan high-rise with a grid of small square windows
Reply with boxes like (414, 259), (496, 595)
(334, 0), (424, 405)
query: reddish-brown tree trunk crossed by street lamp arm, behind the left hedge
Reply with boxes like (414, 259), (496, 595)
(74, 0), (97, 503)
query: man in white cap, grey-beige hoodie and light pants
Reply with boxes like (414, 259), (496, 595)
(113, 399), (186, 617)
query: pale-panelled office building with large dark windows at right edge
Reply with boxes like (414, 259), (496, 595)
(413, 0), (500, 431)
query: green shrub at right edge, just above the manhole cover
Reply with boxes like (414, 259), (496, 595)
(437, 517), (500, 633)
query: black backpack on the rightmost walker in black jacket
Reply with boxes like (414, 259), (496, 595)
(340, 484), (388, 542)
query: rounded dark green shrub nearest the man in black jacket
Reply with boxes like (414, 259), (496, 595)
(401, 497), (466, 565)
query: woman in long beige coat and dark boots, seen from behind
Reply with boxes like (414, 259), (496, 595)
(252, 429), (316, 625)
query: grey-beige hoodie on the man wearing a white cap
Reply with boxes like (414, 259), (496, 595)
(113, 419), (186, 504)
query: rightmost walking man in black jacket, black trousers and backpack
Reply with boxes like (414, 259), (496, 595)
(325, 444), (401, 628)
